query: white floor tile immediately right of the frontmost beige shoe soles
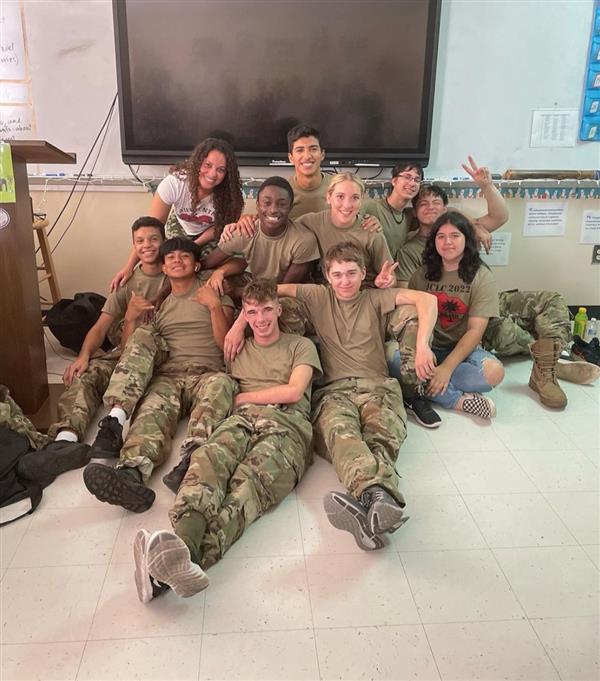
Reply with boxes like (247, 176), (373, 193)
(204, 556), (312, 634)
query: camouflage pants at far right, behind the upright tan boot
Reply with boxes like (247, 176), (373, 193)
(482, 291), (572, 357)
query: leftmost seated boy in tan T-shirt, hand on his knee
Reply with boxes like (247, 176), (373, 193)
(20, 216), (165, 480)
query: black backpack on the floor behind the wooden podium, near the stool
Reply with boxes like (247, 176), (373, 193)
(45, 293), (112, 353)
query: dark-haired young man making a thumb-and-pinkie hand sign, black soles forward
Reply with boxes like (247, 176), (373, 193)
(83, 237), (235, 512)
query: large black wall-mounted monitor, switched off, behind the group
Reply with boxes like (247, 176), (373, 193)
(112, 0), (441, 166)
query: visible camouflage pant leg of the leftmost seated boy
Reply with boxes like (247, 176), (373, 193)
(48, 351), (119, 441)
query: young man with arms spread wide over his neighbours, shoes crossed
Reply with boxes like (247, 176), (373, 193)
(278, 242), (437, 550)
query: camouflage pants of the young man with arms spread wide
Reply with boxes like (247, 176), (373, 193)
(313, 378), (406, 500)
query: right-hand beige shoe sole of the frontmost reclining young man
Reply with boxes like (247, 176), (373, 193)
(146, 530), (209, 598)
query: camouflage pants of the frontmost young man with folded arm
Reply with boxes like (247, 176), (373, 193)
(169, 405), (312, 569)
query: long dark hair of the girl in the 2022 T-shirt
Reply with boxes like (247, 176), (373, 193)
(423, 210), (487, 284)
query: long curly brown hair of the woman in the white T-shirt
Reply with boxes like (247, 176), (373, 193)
(169, 137), (244, 239)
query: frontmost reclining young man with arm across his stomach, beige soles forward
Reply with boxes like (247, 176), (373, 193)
(134, 279), (321, 602)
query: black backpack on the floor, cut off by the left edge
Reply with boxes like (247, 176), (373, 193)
(0, 426), (43, 527)
